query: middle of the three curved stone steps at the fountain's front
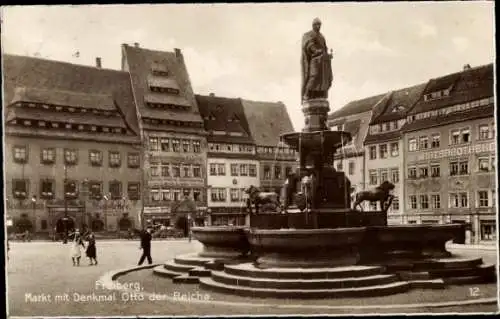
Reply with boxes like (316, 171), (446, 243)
(212, 271), (398, 290)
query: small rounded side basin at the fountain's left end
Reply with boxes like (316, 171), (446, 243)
(192, 226), (250, 258)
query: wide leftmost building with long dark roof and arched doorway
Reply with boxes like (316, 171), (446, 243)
(3, 55), (142, 233)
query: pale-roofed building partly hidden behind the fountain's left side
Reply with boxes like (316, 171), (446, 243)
(242, 100), (298, 194)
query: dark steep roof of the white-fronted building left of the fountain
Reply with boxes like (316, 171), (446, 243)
(196, 95), (253, 143)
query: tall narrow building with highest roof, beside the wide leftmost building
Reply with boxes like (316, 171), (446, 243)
(122, 44), (207, 227)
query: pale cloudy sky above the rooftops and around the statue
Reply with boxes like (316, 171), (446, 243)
(2, 1), (495, 130)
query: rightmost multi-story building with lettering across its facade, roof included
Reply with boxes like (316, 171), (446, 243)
(403, 64), (496, 243)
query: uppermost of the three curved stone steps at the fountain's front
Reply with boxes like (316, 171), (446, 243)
(224, 263), (384, 279)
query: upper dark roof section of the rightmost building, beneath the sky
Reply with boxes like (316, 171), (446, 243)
(409, 64), (494, 114)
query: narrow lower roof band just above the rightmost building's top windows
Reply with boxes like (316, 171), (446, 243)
(402, 105), (495, 132)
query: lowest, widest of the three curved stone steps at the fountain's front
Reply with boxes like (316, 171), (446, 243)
(200, 278), (410, 299)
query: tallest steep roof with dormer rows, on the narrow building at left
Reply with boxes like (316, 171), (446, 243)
(122, 44), (203, 127)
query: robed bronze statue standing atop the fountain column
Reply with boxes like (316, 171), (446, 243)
(301, 18), (333, 102)
